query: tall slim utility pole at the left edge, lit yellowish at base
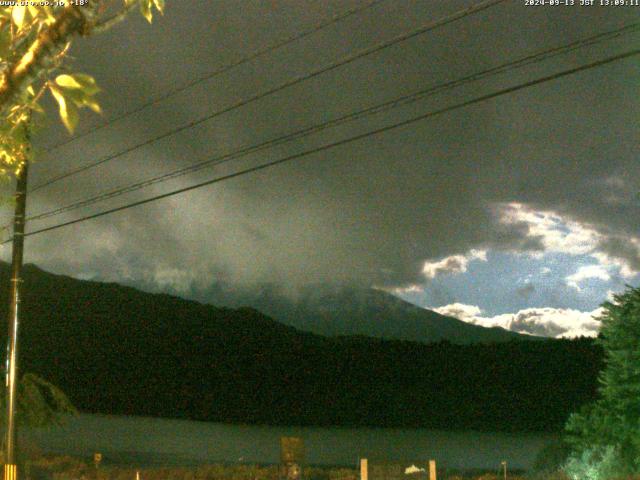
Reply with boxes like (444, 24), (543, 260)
(4, 160), (29, 480)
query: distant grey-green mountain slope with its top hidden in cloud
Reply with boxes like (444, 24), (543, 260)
(201, 286), (540, 344)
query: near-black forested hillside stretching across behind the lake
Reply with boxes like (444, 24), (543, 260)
(0, 264), (601, 431)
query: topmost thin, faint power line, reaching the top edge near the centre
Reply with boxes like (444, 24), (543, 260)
(45, 0), (386, 153)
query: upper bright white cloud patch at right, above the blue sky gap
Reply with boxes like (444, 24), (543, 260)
(497, 202), (640, 282)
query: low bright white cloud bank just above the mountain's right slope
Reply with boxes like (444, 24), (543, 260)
(433, 303), (602, 338)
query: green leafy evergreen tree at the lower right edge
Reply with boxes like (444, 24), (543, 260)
(567, 288), (640, 478)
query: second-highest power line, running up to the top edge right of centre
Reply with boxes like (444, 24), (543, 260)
(31, 0), (506, 192)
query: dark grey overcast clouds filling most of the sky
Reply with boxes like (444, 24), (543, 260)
(5, 0), (640, 334)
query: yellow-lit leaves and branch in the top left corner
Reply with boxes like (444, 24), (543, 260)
(0, 0), (164, 177)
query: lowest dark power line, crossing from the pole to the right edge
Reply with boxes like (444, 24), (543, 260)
(7, 49), (640, 244)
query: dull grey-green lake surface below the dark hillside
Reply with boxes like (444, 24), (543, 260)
(22, 415), (554, 470)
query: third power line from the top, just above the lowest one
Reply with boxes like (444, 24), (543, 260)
(27, 23), (640, 221)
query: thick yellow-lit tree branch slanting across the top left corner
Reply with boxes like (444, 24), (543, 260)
(0, 0), (96, 114)
